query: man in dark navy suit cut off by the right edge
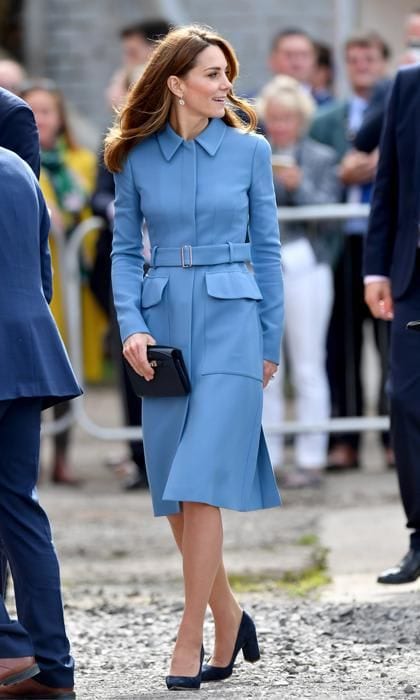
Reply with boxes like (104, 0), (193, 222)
(364, 66), (420, 583)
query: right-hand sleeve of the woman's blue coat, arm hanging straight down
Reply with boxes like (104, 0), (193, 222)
(249, 137), (283, 364)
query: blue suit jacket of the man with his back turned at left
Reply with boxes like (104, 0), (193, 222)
(0, 148), (81, 407)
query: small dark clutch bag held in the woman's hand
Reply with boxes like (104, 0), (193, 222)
(125, 345), (191, 398)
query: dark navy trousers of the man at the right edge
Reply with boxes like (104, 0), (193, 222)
(390, 253), (420, 550)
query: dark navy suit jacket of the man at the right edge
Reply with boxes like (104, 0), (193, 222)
(364, 66), (420, 299)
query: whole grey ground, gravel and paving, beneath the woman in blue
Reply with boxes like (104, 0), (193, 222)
(27, 394), (420, 700)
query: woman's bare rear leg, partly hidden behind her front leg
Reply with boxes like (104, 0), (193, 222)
(168, 513), (242, 666)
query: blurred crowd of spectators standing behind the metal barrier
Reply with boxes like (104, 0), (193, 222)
(0, 12), (420, 489)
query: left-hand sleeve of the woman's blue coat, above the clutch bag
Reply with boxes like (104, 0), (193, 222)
(111, 156), (150, 342)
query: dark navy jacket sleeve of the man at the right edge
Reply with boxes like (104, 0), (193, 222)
(364, 74), (400, 277)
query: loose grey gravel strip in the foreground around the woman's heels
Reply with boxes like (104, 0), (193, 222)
(66, 587), (420, 700)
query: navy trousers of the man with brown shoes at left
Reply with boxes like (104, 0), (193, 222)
(0, 398), (74, 688)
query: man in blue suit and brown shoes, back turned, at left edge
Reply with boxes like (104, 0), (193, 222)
(0, 148), (81, 700)
